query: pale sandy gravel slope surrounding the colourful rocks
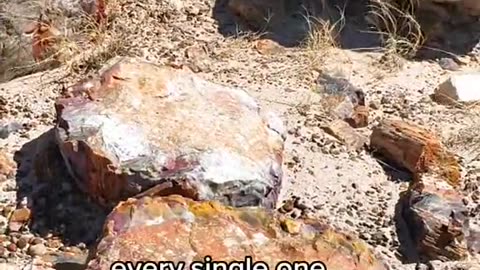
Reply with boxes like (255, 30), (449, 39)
(0, 0), (480, 269)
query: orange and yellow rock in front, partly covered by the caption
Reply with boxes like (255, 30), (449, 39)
(87, 195), (386, 270)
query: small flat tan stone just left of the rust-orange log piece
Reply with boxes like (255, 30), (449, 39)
(323, 119), (368, 150)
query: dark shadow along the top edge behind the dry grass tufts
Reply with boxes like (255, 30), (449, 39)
(213, 0), (480, 61)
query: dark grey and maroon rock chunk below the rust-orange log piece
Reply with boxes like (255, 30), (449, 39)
(401, 175), (472, 261)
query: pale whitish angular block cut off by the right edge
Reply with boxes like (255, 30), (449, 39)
(433, 72), (480, 104)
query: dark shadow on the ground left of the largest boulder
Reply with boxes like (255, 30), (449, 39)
(14, 129), (108, 246)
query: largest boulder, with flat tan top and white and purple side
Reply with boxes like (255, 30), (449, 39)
(56, 58), (285, 208)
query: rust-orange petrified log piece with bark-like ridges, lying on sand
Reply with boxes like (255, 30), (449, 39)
(370, 119), (460, 187)
